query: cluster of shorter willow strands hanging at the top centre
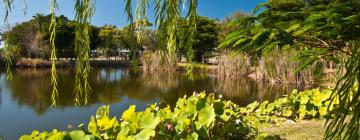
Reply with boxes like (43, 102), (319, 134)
(125, 0), (198, 65)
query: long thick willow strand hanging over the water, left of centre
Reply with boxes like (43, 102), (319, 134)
(74, 0), (95, 105)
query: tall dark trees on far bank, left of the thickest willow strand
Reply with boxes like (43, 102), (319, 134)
(5, 14), (81, 58)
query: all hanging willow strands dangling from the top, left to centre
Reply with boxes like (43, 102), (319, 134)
(3, 0), (198, 106)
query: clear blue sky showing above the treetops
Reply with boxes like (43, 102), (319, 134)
(0, 0), (266, 28)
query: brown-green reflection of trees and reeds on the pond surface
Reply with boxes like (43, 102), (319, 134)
(0, 68), (293, 115)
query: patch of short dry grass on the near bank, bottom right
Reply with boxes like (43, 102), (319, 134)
(259, 119), (326, 140)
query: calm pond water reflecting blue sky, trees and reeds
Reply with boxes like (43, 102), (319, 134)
(0, 69), (291, 140)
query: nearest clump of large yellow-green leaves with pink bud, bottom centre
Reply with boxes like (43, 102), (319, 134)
(20, 93), (263, 140)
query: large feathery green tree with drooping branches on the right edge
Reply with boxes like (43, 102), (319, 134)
(220, 0), (360, 139)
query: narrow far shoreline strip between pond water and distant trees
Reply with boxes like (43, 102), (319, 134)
(0, 58), (335, 87)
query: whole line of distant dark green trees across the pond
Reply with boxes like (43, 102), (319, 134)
(2, 13), (220, 62)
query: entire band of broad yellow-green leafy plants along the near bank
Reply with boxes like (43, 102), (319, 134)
(20, 85), (358, 140)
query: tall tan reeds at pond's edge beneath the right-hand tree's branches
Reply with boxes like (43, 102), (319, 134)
(217, 49), (338, 85)
